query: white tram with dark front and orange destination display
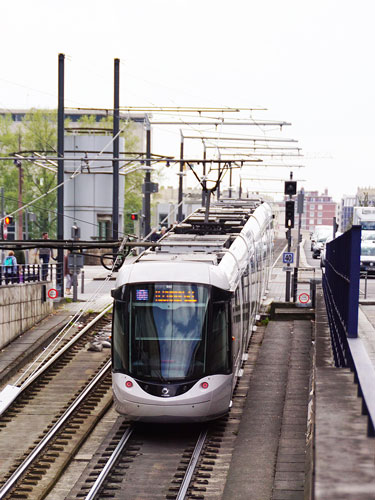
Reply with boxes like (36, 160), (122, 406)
(112, 199), (273, 422)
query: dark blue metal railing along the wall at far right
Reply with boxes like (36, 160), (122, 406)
(323, 226), (375, 437)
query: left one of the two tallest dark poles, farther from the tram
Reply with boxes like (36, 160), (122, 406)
(56, 54), (65, 297)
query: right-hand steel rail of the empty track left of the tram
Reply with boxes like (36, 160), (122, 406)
(0, 361), (111, 499)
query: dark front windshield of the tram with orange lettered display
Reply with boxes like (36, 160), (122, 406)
(113, 283), (230, 382)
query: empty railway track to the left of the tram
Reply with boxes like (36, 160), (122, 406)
(0, 311), (112, 499)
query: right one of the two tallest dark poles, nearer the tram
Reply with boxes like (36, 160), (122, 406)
(112, 59), (120, 240)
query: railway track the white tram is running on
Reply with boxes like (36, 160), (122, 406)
(65, 327), (264, 500)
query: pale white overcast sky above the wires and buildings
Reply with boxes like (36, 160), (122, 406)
(0, 0), (375, 201)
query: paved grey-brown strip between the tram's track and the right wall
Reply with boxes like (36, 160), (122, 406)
(223, 321), (312, 500)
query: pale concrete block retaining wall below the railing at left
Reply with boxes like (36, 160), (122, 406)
(0, 281), (53, 348)
